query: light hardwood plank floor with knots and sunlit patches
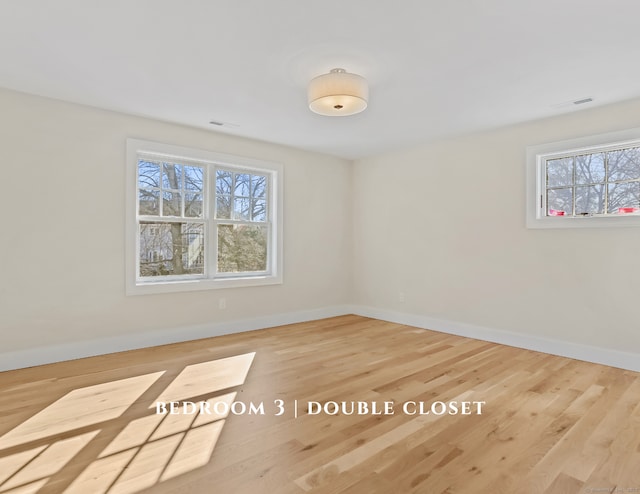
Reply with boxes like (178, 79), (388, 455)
(0, 316), (640, 494)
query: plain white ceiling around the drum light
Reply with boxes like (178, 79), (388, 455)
(0, 0), (640, 158)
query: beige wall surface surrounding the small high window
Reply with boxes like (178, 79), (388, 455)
(353, 100), (640, 354)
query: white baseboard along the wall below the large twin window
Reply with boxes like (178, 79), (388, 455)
(0, 305), (351, 372)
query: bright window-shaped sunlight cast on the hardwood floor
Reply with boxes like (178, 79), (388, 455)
(0, 353), (255, 494)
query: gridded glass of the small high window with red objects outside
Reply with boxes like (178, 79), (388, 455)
(543, 146), (640, 217)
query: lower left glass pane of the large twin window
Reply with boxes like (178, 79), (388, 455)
(139, 222), (205, 277)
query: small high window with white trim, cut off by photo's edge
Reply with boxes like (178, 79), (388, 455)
(527, 129), (640, 228)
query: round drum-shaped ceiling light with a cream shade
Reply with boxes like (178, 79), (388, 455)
(307, 69), (369, 117)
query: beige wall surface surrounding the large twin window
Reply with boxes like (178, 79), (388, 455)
(0, 90), (351, 360)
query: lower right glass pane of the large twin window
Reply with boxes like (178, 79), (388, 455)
(218, 225), (268, 273)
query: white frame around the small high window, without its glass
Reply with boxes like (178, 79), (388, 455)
(526, 128), (640, 228)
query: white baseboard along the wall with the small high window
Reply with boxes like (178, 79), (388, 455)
(351, 306), (640, 372)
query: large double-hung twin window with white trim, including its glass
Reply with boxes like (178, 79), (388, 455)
(127, 139), (282, 293)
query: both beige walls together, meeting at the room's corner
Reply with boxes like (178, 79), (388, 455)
(0, 86), (640, 368)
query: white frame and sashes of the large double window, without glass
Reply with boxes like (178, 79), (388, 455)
(125, 139), (283, 295)
